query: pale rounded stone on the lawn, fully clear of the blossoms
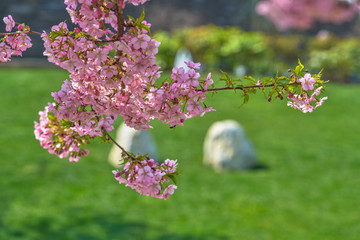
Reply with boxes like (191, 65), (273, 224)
(203, 120), (258, 171)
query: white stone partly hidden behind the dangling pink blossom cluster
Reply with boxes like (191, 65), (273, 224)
(109, 123), (158, 167)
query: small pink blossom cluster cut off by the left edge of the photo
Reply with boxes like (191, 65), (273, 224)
(0, 15), (32, 63)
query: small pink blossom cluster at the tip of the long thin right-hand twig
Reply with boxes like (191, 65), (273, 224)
(287, 73), (327, 113)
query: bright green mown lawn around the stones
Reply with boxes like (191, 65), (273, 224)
(0, 69), (360, 240)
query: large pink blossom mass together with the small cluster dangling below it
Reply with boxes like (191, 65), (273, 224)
(28, 0), (217, 199)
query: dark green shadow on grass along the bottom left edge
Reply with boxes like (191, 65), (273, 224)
(0, 211), (228, 240)
